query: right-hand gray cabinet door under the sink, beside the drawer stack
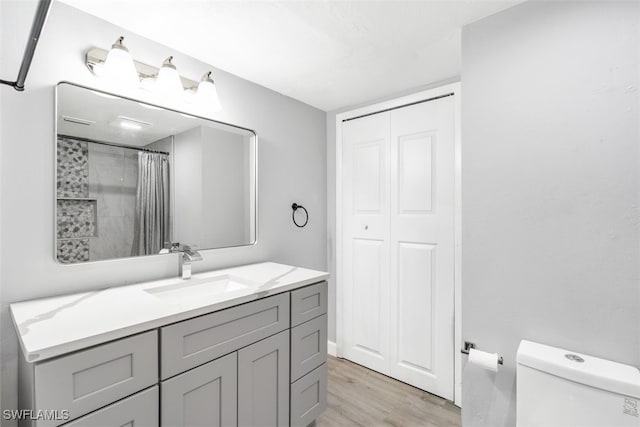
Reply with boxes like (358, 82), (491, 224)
(238, 330), (289, 427)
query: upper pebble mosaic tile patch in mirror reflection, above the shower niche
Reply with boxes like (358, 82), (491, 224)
(56, 136), (89, 197)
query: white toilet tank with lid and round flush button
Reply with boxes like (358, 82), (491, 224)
(516, 340), (640, 427)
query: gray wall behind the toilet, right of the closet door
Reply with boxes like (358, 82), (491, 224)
(462, 1), (640, 427)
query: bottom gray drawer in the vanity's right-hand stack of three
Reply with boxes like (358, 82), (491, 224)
(291, 363), (327, 427)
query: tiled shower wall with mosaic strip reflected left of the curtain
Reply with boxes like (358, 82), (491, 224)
(57, 137), (138, 263)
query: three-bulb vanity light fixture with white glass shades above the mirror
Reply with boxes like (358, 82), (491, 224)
(85, 37), (222, 113)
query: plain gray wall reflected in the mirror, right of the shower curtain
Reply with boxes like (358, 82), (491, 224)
(172, 126), (251, 248)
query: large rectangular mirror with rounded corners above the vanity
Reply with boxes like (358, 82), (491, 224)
(55, 83), (257, 264)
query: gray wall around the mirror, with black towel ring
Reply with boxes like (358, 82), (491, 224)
(0, 2), (326, 425)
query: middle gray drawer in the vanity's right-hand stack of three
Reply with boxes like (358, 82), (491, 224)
(291, 314), (327, 382)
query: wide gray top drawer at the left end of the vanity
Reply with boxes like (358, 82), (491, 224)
(33, 331), (158, 427)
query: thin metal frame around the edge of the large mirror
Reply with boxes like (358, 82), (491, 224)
(53, 80), (259, 266)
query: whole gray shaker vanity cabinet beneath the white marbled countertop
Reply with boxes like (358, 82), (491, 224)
(19, 282), (327, 427)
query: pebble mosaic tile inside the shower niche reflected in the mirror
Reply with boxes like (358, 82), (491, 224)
(57, 199), (97, 239)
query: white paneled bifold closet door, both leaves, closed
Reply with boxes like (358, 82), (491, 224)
(342, 97), (454, 399)
